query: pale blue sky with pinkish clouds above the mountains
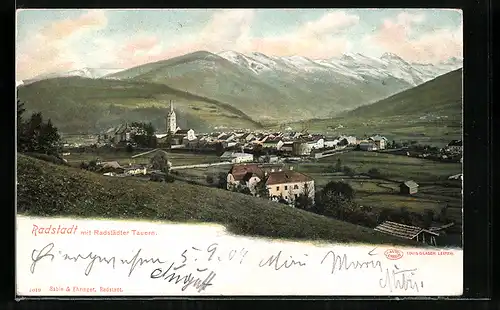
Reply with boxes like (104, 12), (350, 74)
(16, 9), (463, 80)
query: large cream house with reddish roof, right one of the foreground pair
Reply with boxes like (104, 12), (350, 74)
(266, 170), (315, 203)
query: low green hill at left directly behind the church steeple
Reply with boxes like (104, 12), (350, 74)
(18, 77), (260, 133)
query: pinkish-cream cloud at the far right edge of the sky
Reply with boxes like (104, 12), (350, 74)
(364, 13), (463, 63)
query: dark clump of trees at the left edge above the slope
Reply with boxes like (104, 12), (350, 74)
(17, 100), (62, 157)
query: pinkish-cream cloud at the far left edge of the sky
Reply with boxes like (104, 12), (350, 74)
(16, 10), (107, 79)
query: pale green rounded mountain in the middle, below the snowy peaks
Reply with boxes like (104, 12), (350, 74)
(109, 51), (409, 123)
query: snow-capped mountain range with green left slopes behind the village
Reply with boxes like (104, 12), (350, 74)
(18, 51), (462, 130)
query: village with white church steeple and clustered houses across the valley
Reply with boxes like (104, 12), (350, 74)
(63, 102), (462, 245)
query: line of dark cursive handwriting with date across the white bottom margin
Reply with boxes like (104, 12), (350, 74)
(30, 242), (424, 293)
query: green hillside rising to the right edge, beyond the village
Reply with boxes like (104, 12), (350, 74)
(291, 69), (462, 146)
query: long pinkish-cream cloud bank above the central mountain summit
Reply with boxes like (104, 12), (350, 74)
(99, 9), (359, 68)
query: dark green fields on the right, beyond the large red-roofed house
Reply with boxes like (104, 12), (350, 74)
(294, 151), (462, 224)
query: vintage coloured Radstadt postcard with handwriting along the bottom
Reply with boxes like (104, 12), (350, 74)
(16, 9), (463, 298)
